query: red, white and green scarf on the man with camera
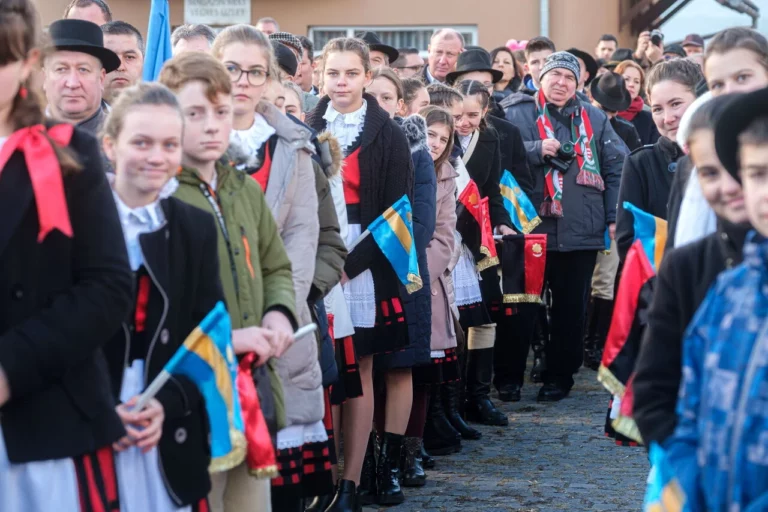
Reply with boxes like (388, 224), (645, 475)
(536, 89), (605, 217)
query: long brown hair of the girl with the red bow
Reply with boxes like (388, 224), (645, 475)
(0, 0), (80, 176)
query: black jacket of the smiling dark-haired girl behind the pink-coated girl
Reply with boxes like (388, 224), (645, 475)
(456, 127), (514, 229)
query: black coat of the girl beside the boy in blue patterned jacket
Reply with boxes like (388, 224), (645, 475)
(633, 220), (749, 446)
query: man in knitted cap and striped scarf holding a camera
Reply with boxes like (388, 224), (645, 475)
(502, 52), (628, 402)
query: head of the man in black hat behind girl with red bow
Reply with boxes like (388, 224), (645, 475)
(43, 19), (120, 135)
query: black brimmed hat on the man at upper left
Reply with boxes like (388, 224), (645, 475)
(48, 19), (120, 73)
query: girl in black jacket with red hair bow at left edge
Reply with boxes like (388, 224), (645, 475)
(0, 0), (131, 512)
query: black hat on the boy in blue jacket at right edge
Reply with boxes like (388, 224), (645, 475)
(715, 88), (768, 181)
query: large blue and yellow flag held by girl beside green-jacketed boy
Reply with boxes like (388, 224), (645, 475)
(163, 302), (246, 472)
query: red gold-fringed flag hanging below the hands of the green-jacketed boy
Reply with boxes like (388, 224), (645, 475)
(237, 353), (277, 478)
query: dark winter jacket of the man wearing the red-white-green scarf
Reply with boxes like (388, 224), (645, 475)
(501, 93), (627, 252)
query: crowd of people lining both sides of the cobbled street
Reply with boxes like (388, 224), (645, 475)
(0, 0), (768, 512)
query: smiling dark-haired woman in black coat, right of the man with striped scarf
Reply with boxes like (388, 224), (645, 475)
(616, 59), (704, 260)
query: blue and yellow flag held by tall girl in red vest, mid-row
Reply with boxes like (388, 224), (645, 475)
(368, 196), (422, 293)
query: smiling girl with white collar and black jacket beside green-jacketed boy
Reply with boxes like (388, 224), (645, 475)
(103, 83), (224, 512)
